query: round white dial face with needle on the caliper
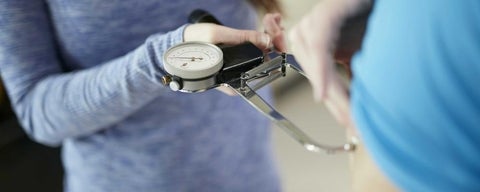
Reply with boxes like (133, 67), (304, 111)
(163, 42), (223, 79)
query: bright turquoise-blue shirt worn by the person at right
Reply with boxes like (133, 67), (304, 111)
(352, 0), (480, 191)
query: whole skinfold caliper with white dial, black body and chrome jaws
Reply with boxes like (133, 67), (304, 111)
(162, 11), (355, 154)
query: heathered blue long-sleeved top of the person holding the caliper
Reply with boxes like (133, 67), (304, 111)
(0, 0), (280, 192)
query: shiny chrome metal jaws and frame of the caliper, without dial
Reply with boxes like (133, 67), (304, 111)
(165, 53), (356, 154)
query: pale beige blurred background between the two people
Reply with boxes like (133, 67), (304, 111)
(273, 0), (351, 192)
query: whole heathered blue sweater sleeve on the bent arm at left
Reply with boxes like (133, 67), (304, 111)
(0, 1), (185, 145)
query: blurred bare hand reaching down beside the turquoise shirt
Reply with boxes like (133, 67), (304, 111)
(289, 0), (369, 128)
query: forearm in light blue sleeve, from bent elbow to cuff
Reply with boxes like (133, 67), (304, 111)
(24, 28), (183, 143)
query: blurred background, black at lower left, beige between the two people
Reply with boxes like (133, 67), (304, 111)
(0, 0), (350, 192)
